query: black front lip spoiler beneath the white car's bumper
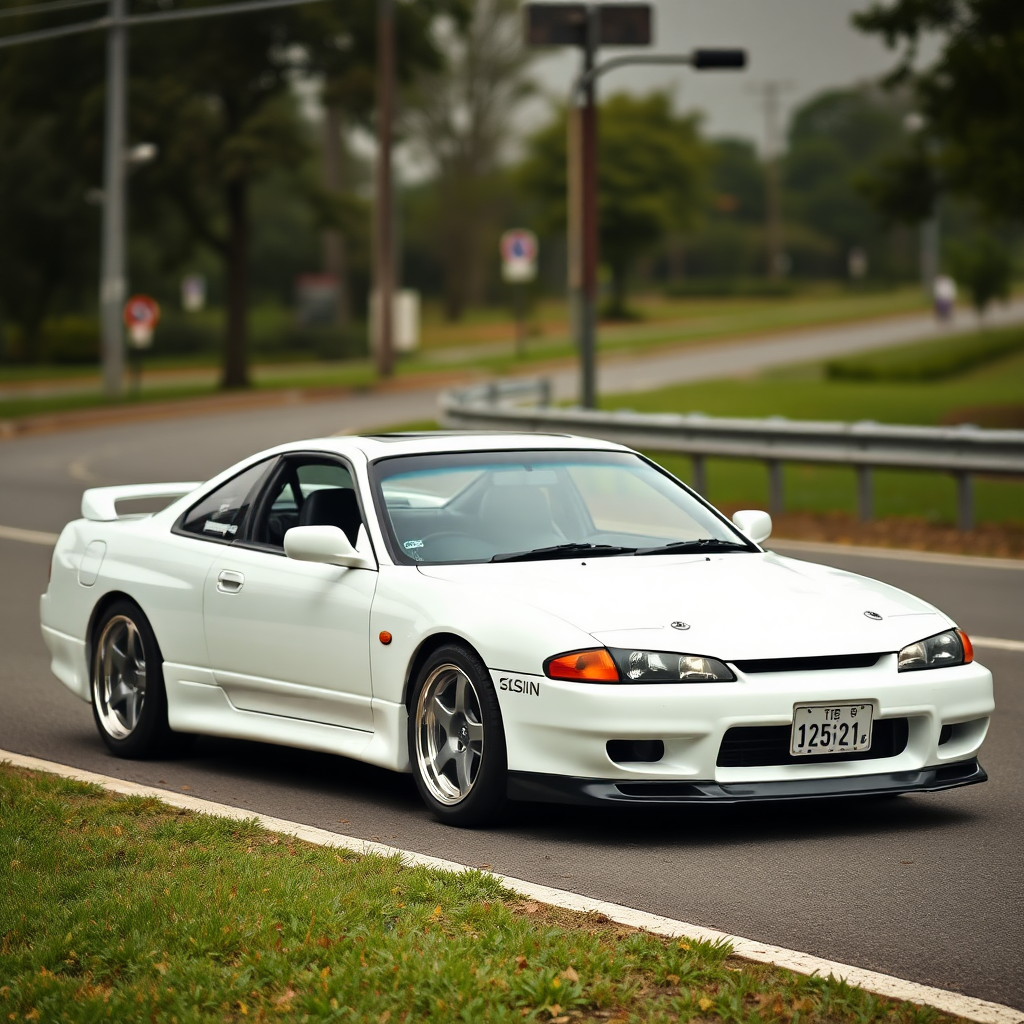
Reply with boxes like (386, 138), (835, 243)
(508, 758), (988, 805)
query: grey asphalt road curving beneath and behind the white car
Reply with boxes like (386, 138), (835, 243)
(0, 344), (1024, 1009)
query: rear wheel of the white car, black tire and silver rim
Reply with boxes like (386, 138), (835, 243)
(89, 599), (191, 759)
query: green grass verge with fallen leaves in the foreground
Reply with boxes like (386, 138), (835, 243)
(0, 766), (948, 1024)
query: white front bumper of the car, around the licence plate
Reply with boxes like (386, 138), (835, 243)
(492, 654), (994, 782)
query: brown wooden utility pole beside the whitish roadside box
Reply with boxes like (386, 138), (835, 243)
(372, 0), (394, 377)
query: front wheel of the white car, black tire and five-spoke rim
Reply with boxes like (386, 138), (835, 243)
(409, 644), (508, 827)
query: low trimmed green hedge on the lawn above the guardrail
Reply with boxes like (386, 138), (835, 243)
(825, 327), (1024, 381)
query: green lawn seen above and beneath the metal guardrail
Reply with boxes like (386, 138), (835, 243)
(601, 343), (1024, 523)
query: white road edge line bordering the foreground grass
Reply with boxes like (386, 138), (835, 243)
(0, 750), (1024, 1024)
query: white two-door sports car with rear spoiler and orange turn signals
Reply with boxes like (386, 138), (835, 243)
(41, 433), (993, 824)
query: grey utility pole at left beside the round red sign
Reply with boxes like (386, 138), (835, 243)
(99, 0), (128, 398)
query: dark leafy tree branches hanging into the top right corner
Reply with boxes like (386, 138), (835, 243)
(853, 0), (1024, 220)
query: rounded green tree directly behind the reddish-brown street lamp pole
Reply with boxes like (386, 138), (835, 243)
(520, 91), (713, 316)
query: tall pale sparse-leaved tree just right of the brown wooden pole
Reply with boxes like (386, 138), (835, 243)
(404, 0), (534, 319)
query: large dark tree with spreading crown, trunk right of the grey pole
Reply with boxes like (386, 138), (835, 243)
(0, 0), (461, 387)
